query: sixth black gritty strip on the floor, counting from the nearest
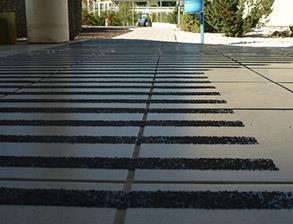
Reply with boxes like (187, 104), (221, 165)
(0, 99), (227, 104)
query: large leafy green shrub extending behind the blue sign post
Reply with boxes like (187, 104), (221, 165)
(180, 0), (274, 37)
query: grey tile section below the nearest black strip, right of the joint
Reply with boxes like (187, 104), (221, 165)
(126, 209), (293, 224)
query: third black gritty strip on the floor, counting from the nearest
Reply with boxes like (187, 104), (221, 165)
(0, 135), (258, 145)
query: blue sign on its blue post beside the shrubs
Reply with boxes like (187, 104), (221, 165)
(184, 0), (204, 44)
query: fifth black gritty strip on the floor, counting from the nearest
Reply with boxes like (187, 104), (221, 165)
(0, 107), (233, 114)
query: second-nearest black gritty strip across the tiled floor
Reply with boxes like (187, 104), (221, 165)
(0, 156), (278, 170)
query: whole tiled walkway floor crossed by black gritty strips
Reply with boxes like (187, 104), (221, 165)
(0, 40), (293, 224)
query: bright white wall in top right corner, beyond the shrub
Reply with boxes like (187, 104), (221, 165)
(267, 0), (293, 26)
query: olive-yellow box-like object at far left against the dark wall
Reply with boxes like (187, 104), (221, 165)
(0, 12), (16, 45)
